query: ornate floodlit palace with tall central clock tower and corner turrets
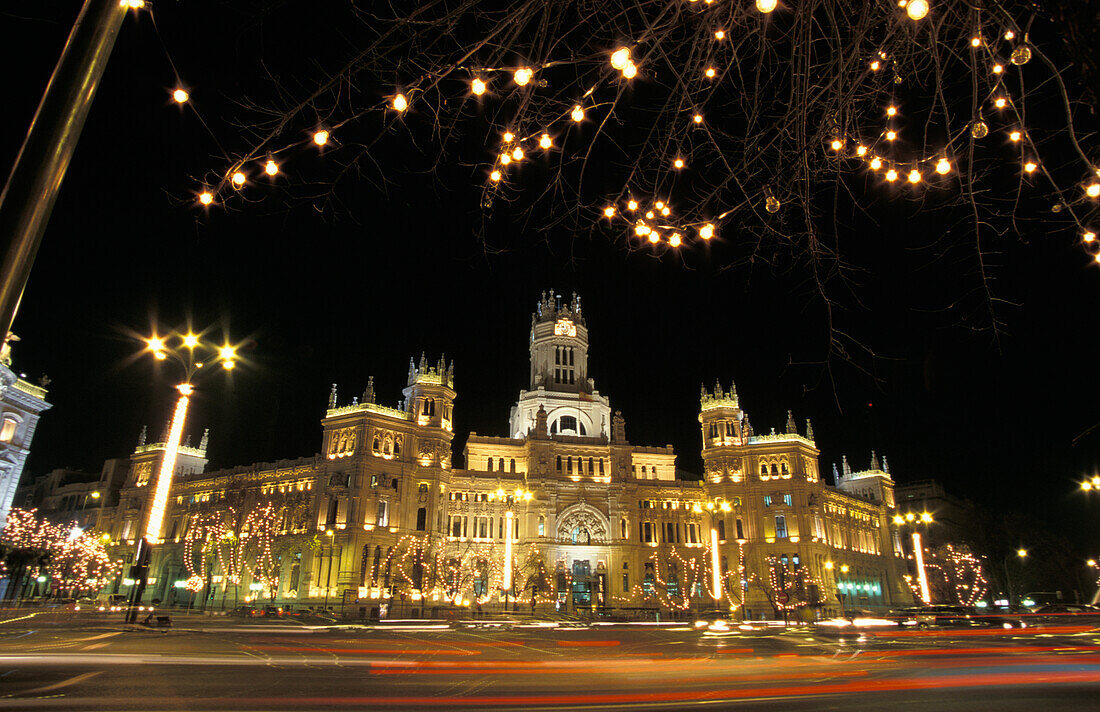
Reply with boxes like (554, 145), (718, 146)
(105, 295), (912, 617)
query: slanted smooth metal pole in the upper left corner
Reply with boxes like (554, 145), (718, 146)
(0, 0), (128, 336)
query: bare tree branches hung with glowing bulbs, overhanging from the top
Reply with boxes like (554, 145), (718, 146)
(160, 0), (1100, 350)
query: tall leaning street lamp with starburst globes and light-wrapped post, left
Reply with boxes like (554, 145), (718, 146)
(127, 330), (237, 623)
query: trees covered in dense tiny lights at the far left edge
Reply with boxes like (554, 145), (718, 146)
(0, 507), (122, 599)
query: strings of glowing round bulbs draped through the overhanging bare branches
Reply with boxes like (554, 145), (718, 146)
(113, 0), (1100, 263)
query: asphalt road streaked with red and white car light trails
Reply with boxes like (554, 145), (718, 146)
(0, 620), (1100, 712)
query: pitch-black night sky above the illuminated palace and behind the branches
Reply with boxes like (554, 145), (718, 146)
(0, 2), (1100, 541)
